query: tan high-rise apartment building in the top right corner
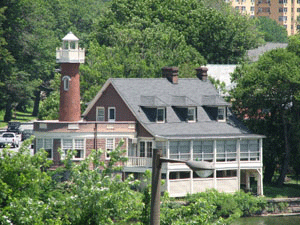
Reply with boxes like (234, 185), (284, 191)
(225, 0), (300, 35)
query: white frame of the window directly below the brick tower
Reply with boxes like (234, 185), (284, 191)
(61, 138), (85, 160)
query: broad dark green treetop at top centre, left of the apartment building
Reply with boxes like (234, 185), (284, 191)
(95, 0), (260, 63)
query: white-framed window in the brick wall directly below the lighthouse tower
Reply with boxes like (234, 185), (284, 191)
(62, 138), (85, 160)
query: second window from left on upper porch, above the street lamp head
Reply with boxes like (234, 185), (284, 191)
(193, 141), (214, 162)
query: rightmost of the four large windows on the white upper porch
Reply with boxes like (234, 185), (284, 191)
(240, 140), (259, 161)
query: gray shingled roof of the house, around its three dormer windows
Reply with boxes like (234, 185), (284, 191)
(108, 78), (257, 139)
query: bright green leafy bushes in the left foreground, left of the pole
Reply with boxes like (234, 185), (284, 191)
(0, 139), (142, 225)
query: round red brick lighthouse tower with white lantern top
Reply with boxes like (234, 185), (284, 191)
(56, 32), (84, 121)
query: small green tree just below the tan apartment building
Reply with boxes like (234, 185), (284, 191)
(256, 16), (288, 43)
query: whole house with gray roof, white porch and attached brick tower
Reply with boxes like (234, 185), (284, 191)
(34, 31), (263, 197)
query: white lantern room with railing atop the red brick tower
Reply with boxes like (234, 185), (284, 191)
(56, 32), (85, 63)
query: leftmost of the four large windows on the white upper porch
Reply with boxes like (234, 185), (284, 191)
(169, 141), (191, 160)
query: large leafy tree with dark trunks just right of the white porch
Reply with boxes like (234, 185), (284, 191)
(231, 49), (300, 185)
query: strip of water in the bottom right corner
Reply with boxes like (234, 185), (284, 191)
(232, 216), (300, 225)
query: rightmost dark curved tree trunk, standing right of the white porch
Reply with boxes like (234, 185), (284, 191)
(277, 115), (290, 186)
